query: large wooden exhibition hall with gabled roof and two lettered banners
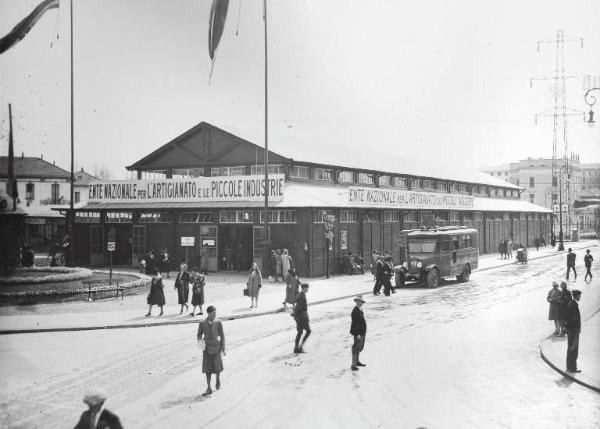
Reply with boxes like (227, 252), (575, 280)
(75, 123), (551, 276)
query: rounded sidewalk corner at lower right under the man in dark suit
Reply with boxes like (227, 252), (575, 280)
(540, 311), (600, 392)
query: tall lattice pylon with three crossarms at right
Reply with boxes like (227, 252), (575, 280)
(529, 30), (585, 251)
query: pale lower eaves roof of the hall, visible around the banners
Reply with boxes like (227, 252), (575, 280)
(81, 182), (551, 213)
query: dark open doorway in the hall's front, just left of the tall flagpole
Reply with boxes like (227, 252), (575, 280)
(218, 224), (253, 271)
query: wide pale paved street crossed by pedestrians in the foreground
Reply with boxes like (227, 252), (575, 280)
(0, 248), (600, 428)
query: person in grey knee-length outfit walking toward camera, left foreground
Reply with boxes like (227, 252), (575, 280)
(196, 305), (226, 396)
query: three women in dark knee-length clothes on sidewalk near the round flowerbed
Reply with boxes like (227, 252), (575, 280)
(146, 264), (206, 317)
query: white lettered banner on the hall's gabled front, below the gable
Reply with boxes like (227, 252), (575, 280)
(88, 174), (285, 203)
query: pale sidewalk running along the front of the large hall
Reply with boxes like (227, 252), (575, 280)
(0, 240), (597, 334)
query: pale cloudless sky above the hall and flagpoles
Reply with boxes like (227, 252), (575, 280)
(0, 0), (600, 178)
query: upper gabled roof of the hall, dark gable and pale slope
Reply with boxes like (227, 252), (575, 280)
(127, 122), (520, 189)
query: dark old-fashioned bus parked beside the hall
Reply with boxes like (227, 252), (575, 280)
(394, 226), (479, 287)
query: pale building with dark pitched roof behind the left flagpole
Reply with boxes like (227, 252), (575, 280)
(0, 154), (96, 251)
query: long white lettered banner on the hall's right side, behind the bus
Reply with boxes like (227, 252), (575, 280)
(348, 186), (475, 210)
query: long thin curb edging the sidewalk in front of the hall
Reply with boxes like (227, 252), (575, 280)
(0, 244), (598, 334)
